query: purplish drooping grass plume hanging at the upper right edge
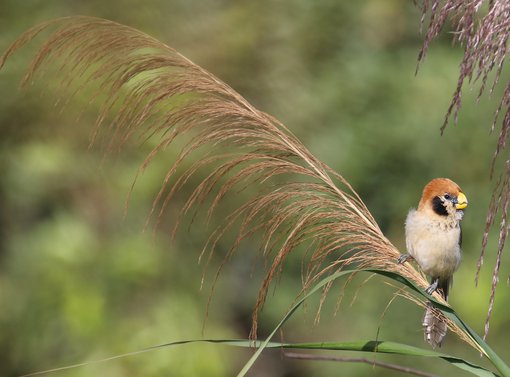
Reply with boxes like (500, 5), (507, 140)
(415, 0), (510, 337)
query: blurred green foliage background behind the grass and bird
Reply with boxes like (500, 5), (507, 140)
(0, 0), (510, 377)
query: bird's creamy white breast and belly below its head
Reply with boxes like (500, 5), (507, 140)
(405, 209), (461, 278)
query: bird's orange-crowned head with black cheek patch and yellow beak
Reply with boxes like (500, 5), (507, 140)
(418, 178), (468, 218)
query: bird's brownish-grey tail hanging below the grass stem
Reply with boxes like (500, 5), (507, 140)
(422, 279), (451, 348)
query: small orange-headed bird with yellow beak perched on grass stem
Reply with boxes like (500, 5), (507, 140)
(398, 178), (468, 348)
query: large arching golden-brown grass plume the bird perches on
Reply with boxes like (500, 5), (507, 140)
(0, 17), (468, 344)
